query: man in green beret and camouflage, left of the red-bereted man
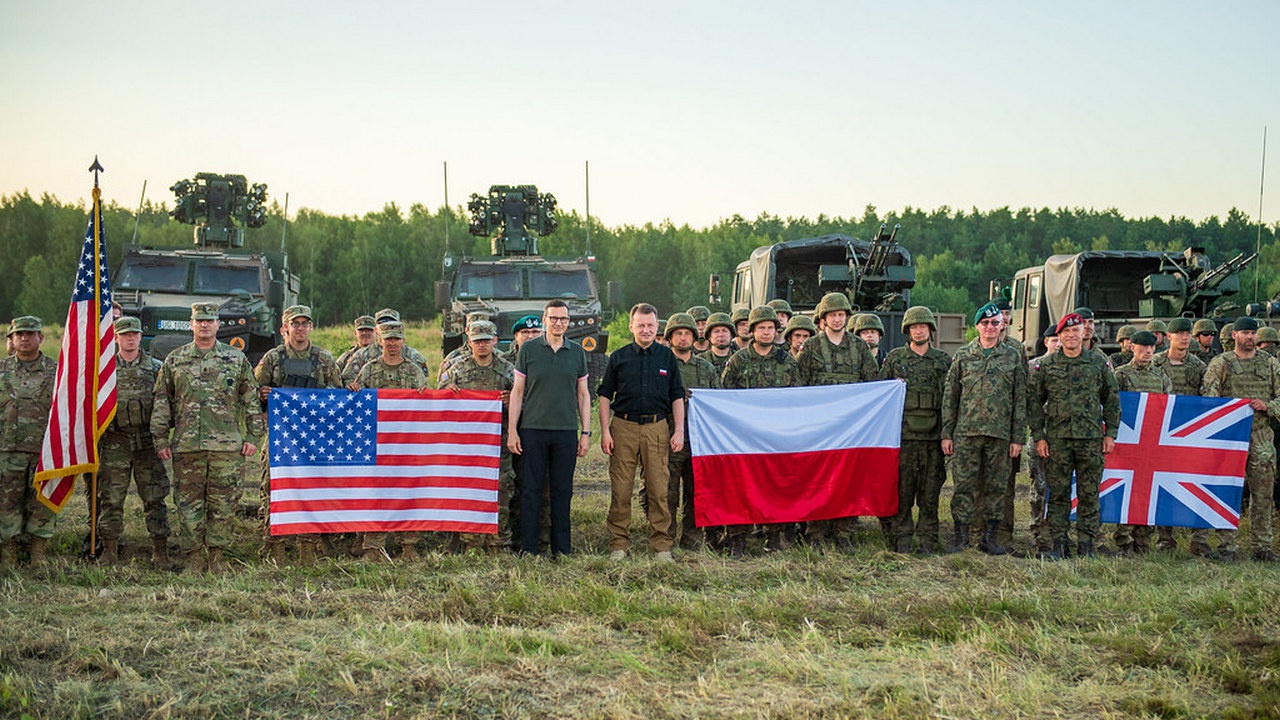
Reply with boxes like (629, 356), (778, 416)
(941, 302), (1027, 555)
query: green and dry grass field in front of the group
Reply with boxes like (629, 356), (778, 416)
(0, 322), (1280, 719)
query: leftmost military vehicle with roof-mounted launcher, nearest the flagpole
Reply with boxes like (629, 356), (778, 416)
(113, 173), (301, 363)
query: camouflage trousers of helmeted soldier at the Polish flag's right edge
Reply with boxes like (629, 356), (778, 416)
(891, 439), (947, 552)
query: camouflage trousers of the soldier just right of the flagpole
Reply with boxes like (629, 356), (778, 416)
(92, 425), (169, 538)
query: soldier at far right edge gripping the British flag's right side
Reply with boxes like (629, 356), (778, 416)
(1204, 318), (1280, 562)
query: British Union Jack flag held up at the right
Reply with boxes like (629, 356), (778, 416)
(1098, 392), (1253, 529)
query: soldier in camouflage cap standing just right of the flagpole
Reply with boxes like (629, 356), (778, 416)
(86, 318), (169, 568)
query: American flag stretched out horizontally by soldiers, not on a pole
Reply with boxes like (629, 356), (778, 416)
(268, 388), (503, 536)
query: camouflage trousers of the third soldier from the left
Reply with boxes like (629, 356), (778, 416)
(173, 451), (243, 552)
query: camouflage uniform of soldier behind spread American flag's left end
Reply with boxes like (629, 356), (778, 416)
(253, 343), (343, 561)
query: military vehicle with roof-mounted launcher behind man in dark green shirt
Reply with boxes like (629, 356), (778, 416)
(435, 184), (621, 378)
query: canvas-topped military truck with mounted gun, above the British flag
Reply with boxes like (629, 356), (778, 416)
(992, 247), (1261, 355)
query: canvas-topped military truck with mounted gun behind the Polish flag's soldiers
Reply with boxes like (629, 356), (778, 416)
(710, 225), (965, 352)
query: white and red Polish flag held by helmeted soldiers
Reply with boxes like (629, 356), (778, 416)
(689, 380), (906, 527)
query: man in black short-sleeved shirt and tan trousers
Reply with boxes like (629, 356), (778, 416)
(598, 302), (685, 562)
